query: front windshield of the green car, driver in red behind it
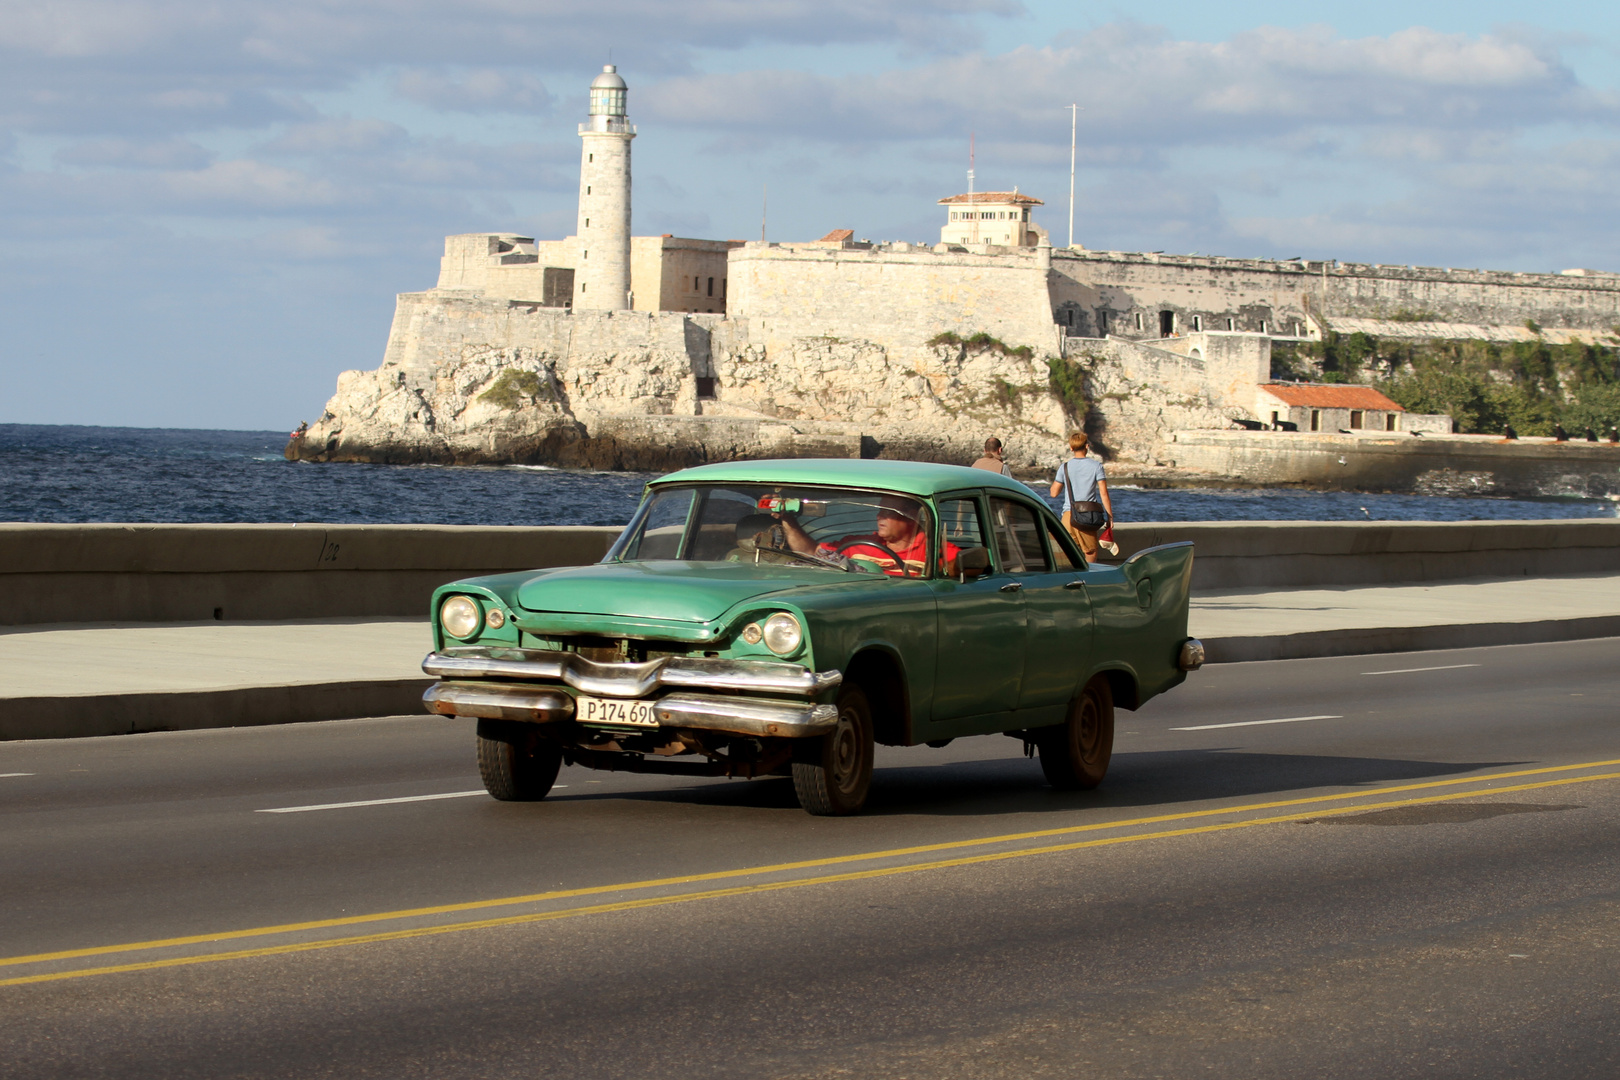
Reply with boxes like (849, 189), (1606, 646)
(609, 484), (933, 576)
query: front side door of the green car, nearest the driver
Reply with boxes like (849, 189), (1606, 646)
(930, 494), (1029, 738)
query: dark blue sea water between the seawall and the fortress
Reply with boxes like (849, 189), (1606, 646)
(0, 424), (1617, 525)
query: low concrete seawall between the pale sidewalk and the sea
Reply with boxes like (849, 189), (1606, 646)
(0, 520), (1620, 625)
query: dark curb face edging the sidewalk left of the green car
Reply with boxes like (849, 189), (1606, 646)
(0, 677), (434, 742)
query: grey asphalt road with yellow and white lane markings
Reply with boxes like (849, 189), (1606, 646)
(0, 640), (1620, 1078)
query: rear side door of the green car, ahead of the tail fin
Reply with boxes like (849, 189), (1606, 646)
(990, 497), (1092, 725)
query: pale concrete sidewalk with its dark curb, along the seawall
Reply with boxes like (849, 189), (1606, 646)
(0, 572), (1620, 740)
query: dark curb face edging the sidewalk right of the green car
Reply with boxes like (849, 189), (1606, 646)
(1204, 615), (1620, 664)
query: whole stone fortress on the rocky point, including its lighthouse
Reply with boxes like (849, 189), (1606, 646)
(287, 65), (1620, 494)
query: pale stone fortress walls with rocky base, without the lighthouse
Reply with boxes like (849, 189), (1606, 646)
(304, 233), (1620, 489)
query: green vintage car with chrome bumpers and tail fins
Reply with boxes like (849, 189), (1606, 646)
(423, 460), (1204, 814)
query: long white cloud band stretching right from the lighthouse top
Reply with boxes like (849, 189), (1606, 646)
(642, 23), (1620, 146)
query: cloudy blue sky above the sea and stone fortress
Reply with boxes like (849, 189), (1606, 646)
(0, 0), (1620, 431)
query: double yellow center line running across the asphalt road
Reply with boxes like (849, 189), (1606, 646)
(9, 758), (1620, 986)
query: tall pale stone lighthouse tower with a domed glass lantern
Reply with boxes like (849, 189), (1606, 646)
(573, 63), (635, 311)
